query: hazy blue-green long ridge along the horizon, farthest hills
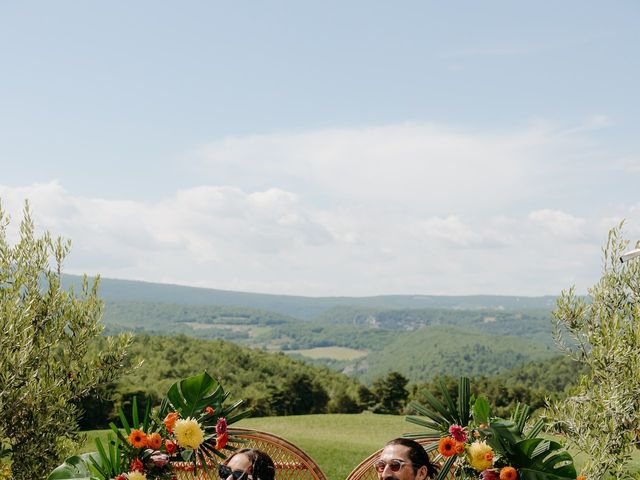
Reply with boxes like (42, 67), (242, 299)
(63, 275), (555, 320)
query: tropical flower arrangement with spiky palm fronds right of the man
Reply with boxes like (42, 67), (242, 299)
(405, 377), (579, 480)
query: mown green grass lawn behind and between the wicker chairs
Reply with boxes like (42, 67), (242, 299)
(82, 413), (640, 480)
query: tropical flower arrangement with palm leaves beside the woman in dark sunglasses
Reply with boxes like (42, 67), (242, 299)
(48, 372), (251, 480)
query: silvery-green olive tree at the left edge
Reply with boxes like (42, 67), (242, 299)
(0, 204), (130, 480)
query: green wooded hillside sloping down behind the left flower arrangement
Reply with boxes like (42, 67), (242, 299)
(82, 335), (361, 428)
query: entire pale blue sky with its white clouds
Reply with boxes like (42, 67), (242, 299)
(0, 0), (640, 296)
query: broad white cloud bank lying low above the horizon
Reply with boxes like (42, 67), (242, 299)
(0, 119), (640, 295)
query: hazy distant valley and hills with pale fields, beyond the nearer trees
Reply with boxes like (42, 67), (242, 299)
(66, 277), (557, 383)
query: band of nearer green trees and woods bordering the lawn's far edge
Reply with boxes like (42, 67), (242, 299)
(77, 334), (577, 429)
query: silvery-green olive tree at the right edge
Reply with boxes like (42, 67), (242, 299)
(551, 224), (640, 479)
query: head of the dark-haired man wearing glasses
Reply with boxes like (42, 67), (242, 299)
(374, 438), (437, 480)
